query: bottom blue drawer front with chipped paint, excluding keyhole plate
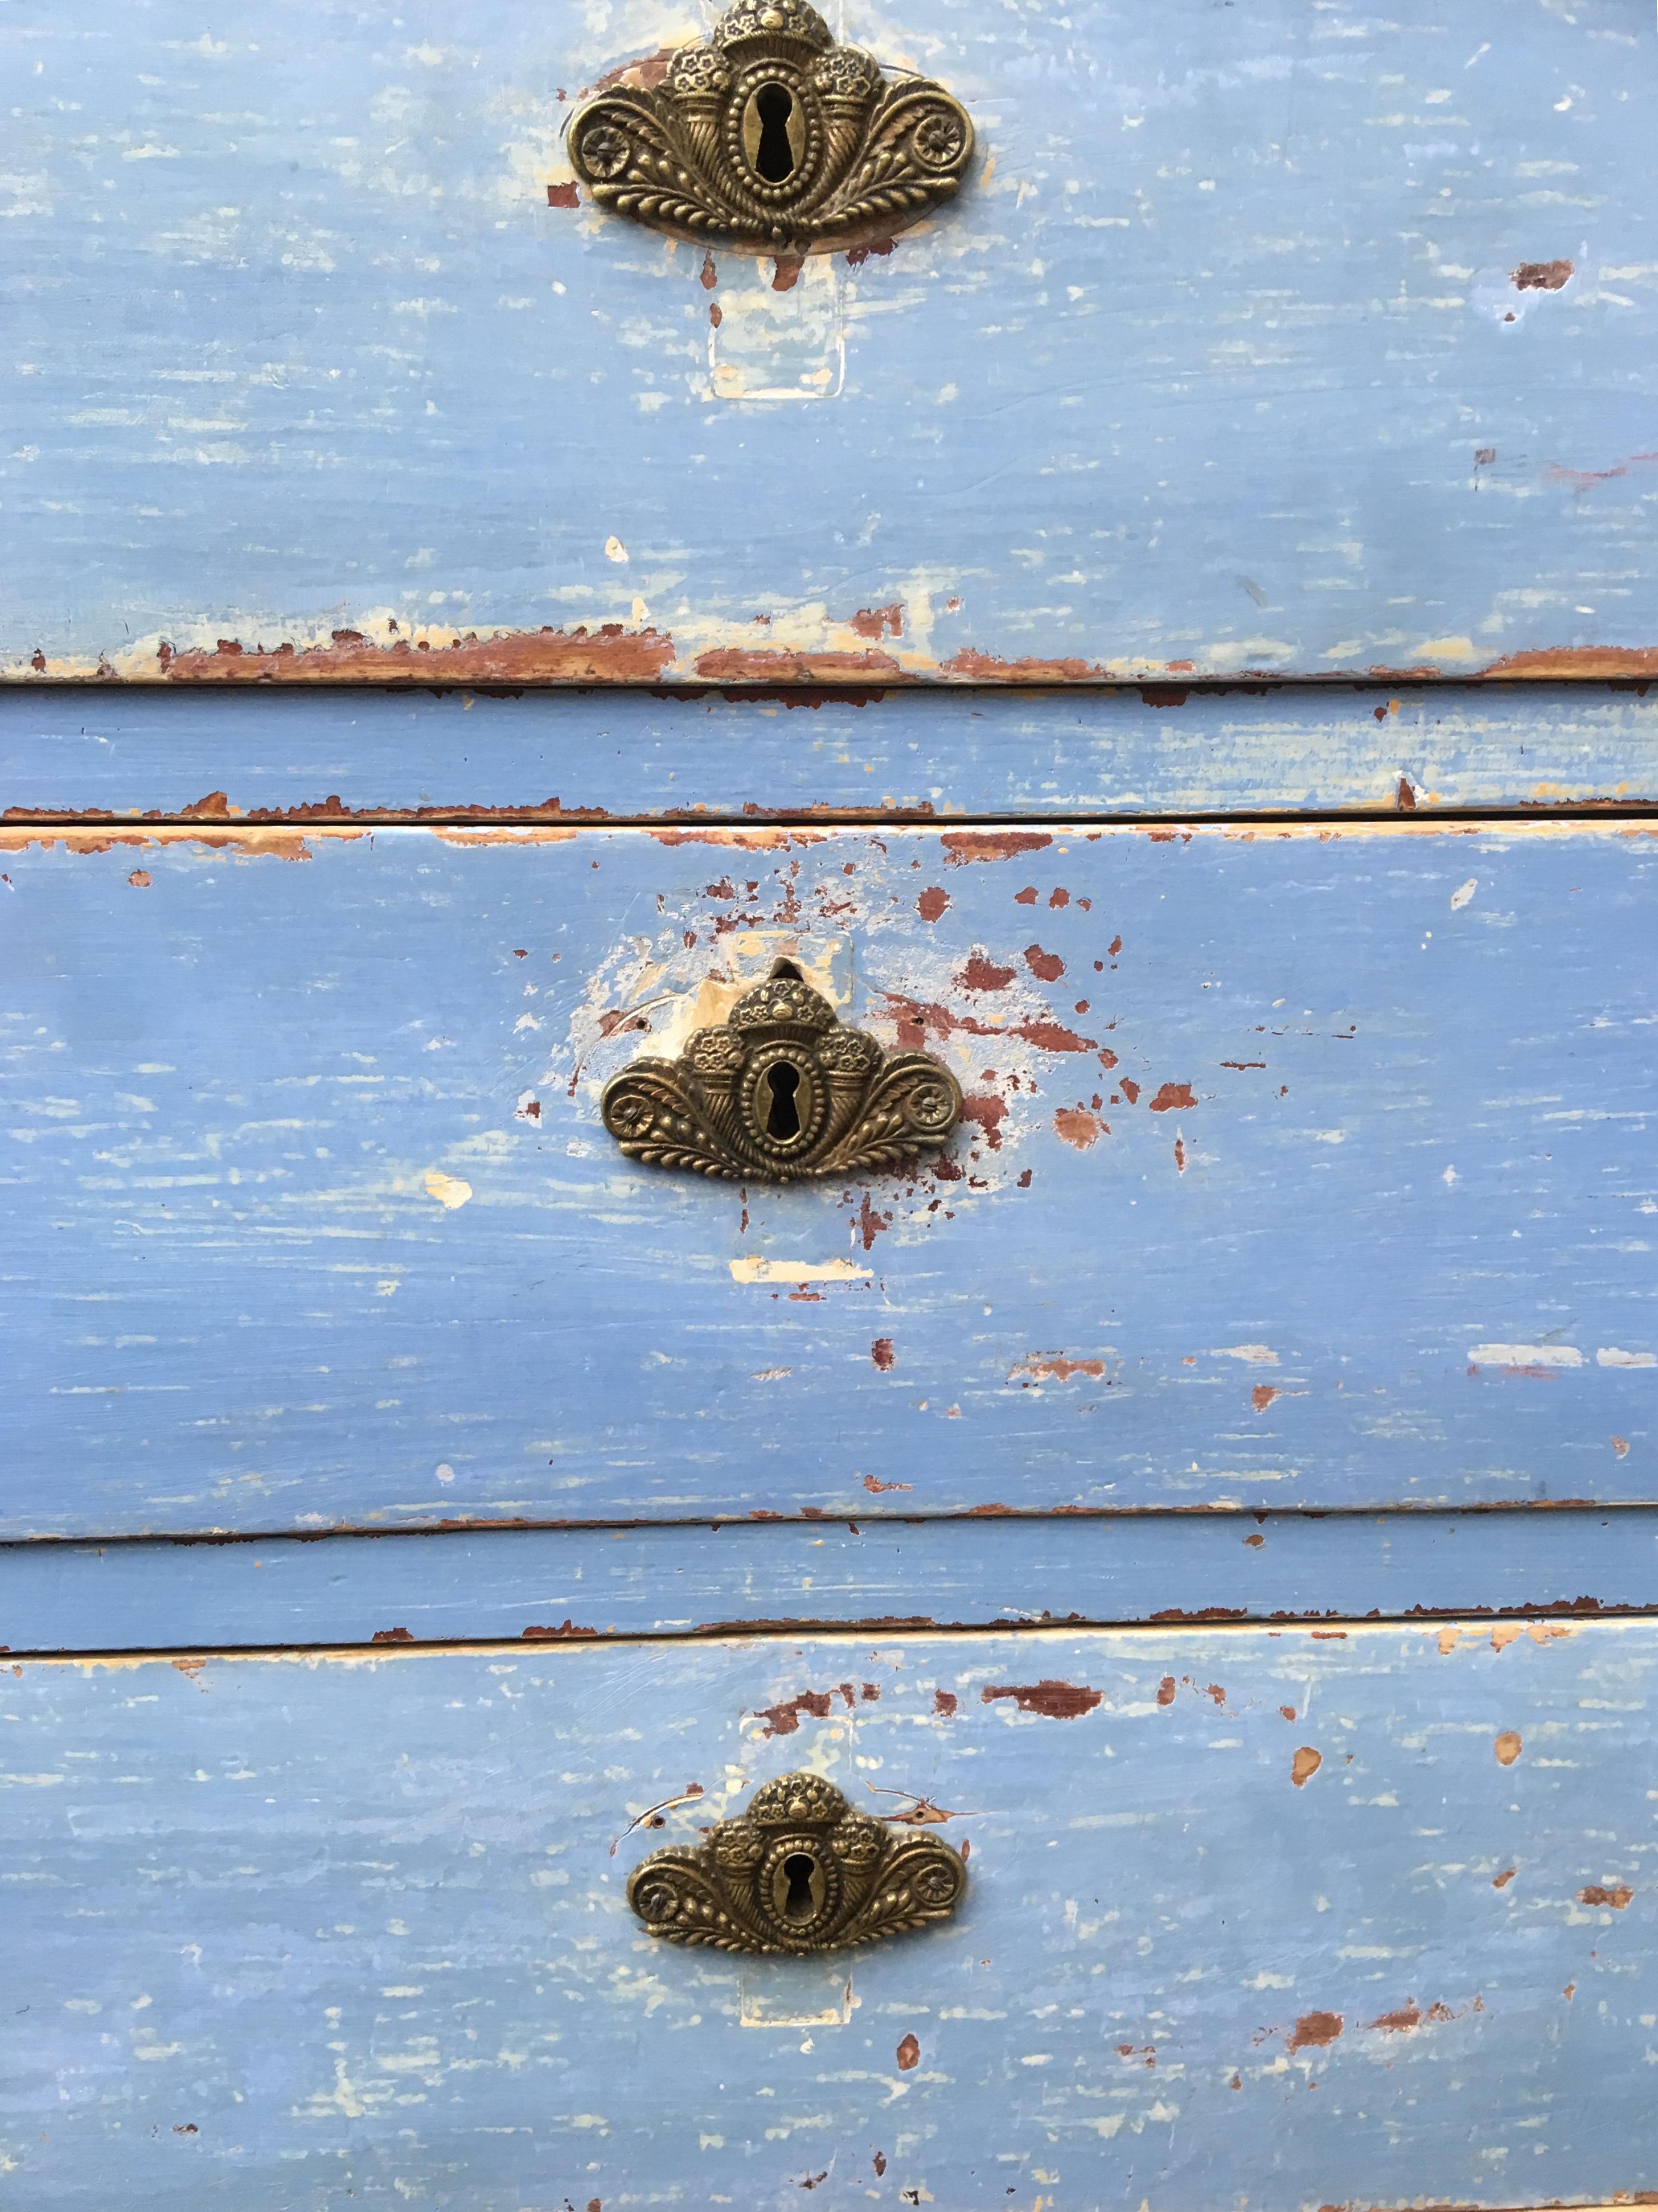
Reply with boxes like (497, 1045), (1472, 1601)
(0, 1622), (1658, 2212)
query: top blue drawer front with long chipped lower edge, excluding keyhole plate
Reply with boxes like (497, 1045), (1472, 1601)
(0, 0), (1658, 682)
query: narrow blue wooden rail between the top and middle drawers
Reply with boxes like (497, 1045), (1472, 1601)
(0, 683), (1658, 823)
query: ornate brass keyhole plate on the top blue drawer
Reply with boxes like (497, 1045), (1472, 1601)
(571, 0), (972, 255)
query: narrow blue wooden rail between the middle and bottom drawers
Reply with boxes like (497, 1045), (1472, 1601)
(0, 1507), (1658, 1652)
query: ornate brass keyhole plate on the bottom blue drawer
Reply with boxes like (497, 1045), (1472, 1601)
(628, 1774), (966, 1953)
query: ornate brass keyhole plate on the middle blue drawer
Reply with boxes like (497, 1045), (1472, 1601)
(604, 960), (962, 1183)
